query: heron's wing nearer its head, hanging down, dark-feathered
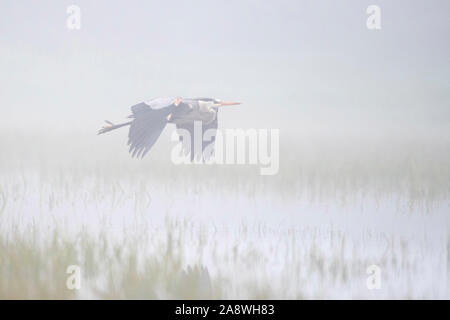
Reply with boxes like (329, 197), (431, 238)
(177, 116), (218, 161)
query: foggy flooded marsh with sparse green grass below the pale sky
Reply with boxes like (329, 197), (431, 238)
(0, 129), (450, 299)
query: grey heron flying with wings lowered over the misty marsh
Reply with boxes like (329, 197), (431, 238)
(98, 97), (240, 161)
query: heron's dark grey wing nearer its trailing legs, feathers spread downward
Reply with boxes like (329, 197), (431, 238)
(128, 100), (175, 158)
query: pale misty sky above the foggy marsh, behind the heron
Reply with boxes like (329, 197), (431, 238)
(0, 0), (450, 135)
